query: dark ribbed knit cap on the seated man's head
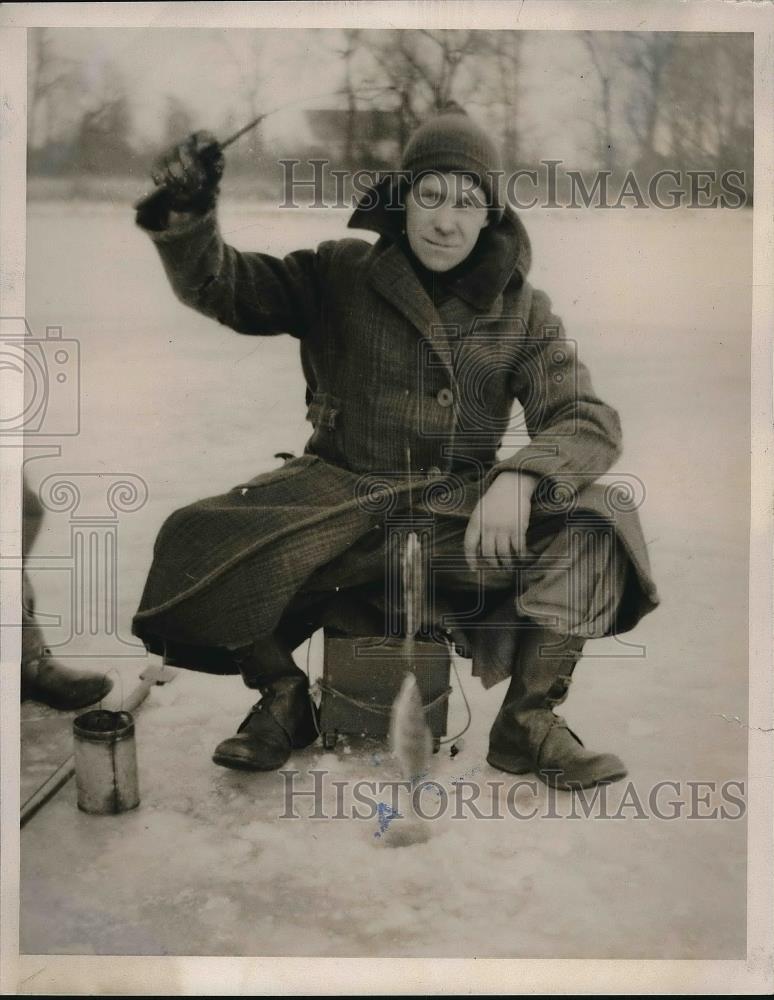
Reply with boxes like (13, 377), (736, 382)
(401, 105), (503, 222)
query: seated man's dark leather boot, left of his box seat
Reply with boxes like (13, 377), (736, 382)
(212, 671), (318, 771)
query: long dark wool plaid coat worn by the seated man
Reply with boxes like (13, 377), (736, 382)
(133, 189), (658, 684)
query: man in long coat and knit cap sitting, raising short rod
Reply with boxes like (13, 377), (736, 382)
(133, 109), (658, 788)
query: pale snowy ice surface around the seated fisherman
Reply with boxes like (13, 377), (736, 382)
(21, 204), (752, 958)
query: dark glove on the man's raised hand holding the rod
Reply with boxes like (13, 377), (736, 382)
(151, 132), (224, 215)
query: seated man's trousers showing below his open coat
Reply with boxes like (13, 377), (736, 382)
(254, 519), (628, 687)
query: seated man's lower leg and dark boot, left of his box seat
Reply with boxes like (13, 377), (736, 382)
(212, 639), (319, 771)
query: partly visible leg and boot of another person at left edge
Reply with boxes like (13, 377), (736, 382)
(21, 481), (113, 711)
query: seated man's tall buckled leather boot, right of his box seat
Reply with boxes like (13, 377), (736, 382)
(486, 628), (626, 790)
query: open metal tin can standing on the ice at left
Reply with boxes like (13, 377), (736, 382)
(73, 709), (140, 815)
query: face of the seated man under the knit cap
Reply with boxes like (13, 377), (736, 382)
(406, 173), (487, 271)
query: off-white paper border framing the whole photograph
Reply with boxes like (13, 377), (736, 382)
(0, 0), (774, 995)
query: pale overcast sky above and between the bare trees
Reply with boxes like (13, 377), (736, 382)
(45, 28), (596, 165)
